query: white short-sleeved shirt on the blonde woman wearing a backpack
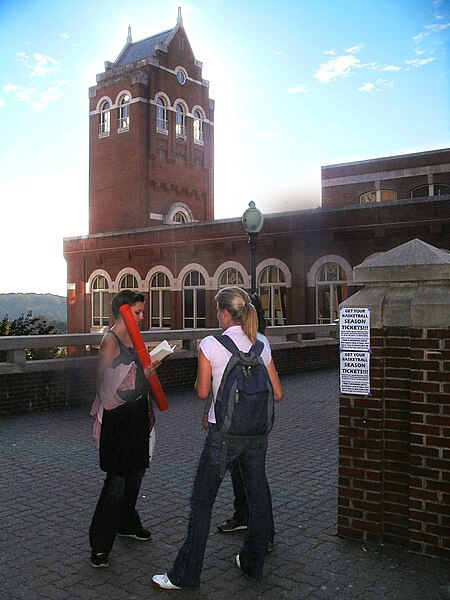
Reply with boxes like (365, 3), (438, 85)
(199, 325), (272, 423)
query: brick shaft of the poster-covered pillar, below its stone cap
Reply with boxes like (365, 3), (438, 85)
(338, 328), (450, 558)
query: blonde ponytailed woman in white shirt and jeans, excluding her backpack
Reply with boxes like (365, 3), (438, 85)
(152, 286), (283, 590)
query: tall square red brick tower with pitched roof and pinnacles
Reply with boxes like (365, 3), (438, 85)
(89, 9), (214, 234)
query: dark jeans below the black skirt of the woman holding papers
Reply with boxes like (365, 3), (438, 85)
(89, 469), (145, 554)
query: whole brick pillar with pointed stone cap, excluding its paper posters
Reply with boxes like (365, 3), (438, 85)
(338, 239), (450, 559)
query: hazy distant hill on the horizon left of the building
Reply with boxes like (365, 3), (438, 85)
(0, 294), (67, 323)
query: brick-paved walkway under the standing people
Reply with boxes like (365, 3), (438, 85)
(0, 370), (450, 600)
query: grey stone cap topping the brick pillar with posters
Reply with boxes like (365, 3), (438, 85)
(340, 239), (450, 328)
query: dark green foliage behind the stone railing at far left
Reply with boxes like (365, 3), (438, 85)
(0, 310), (67, 362)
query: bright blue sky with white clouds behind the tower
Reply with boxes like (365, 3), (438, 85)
(0, 0), (450, 295)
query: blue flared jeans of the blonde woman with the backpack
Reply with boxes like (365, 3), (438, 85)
(168, 424), (271, 588)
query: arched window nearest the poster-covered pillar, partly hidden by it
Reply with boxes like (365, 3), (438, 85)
(316, 263), (347, 323)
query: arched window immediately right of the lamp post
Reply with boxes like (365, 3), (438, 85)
(259, 266), (286, 325)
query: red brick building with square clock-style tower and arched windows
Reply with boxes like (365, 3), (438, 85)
(64, 12), (450, 333)
